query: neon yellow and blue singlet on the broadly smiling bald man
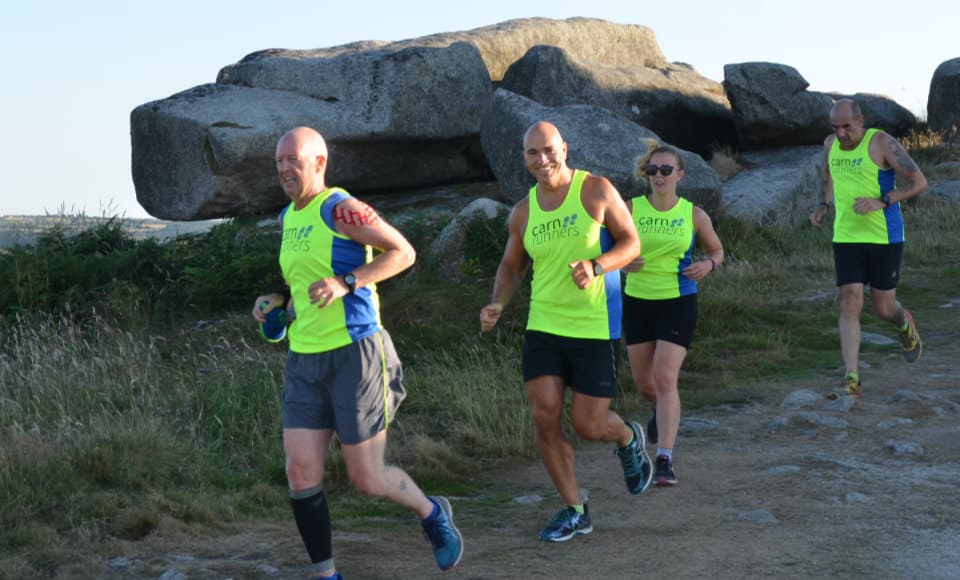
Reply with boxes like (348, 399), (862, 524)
(523, 170), (621, 340)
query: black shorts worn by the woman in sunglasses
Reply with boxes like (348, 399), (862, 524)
(623, 294), (699, 349)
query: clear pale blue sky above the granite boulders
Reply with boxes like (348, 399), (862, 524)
(0, 0), (960, 217)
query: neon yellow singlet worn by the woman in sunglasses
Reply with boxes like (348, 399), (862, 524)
(624, 196), (697, 300)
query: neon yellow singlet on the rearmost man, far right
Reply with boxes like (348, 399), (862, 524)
(828, 129), (905, 244)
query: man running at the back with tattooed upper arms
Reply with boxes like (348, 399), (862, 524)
(810, 99), (927, 399)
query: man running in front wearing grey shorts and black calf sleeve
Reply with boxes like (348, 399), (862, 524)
(252, 127), (463, 580)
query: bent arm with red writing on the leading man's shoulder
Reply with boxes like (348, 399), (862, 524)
(308, 197), (417, 307)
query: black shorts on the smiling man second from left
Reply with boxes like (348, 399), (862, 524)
(523, 330), (620, 399)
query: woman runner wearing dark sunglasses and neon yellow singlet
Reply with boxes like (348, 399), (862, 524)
(623, 141), (723, 486)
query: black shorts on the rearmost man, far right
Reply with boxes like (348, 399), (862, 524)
(833, 242), (903, 290)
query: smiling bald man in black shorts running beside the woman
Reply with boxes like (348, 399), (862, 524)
(480, 122), (652, 542)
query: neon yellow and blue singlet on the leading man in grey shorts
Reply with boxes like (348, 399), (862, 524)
(280, 188), (380, 354)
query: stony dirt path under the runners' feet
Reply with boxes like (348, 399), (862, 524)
(71, 324), (960, 580)
